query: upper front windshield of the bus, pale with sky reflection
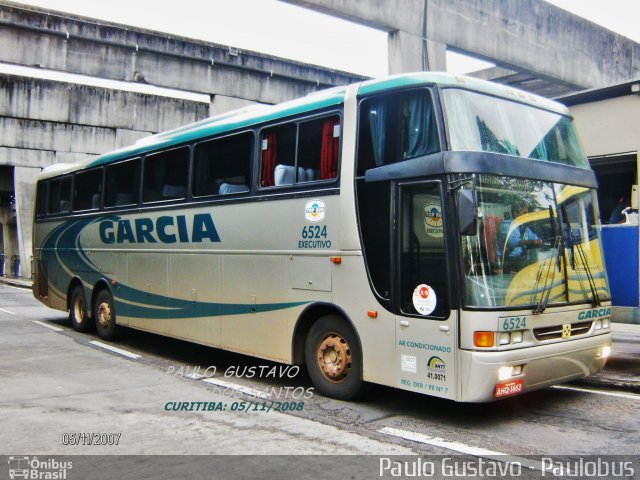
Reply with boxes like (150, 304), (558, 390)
(443, 88), (589, 169)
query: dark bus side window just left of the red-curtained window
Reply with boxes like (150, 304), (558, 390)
(192, 132), (253, 197)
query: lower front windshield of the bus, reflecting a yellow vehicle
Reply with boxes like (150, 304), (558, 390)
(462, 175), (609, 311)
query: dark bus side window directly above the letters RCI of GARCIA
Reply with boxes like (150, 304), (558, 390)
(142, 147), (189, 203)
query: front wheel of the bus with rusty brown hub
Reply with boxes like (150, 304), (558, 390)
(305, 315), (364, 400)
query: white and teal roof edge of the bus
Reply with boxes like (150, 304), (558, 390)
(41, 72), (568, 178)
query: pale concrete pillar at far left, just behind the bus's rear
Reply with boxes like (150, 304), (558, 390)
(14, 167), (40, 278)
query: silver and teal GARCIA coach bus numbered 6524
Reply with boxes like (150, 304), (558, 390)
(33, 72), (611, 402)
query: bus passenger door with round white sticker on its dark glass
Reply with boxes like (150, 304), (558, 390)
(394, 181), (457, 398)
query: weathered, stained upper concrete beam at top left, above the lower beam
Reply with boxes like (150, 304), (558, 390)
(0, 1), (362, 103)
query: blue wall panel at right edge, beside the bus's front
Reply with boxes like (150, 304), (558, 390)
(602, 225), (639, 307)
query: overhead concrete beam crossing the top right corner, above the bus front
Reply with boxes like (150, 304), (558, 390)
(283, 0), (640, 88)
